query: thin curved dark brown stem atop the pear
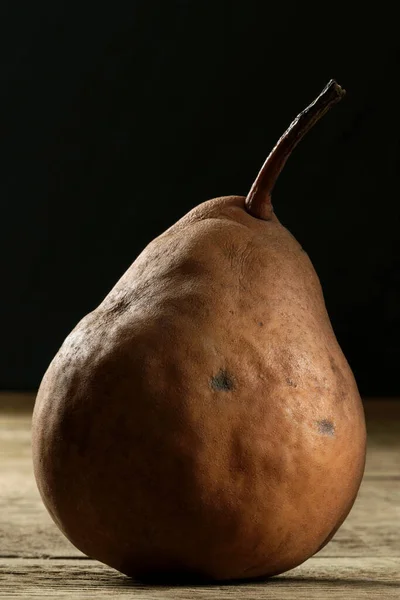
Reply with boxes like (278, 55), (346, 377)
(245, 79), (346, 220)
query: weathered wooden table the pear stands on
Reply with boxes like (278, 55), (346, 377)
(0, 393), (400, 600)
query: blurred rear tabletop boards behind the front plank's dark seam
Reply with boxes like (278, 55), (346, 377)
(0, 403), (400, 558)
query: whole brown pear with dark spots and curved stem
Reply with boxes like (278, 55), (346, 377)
(32, 80), (366, 582)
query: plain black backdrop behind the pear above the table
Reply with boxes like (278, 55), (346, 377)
(0, 0), (400, 395)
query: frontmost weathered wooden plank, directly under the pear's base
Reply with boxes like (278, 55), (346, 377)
(0, 557), (400, 600)
